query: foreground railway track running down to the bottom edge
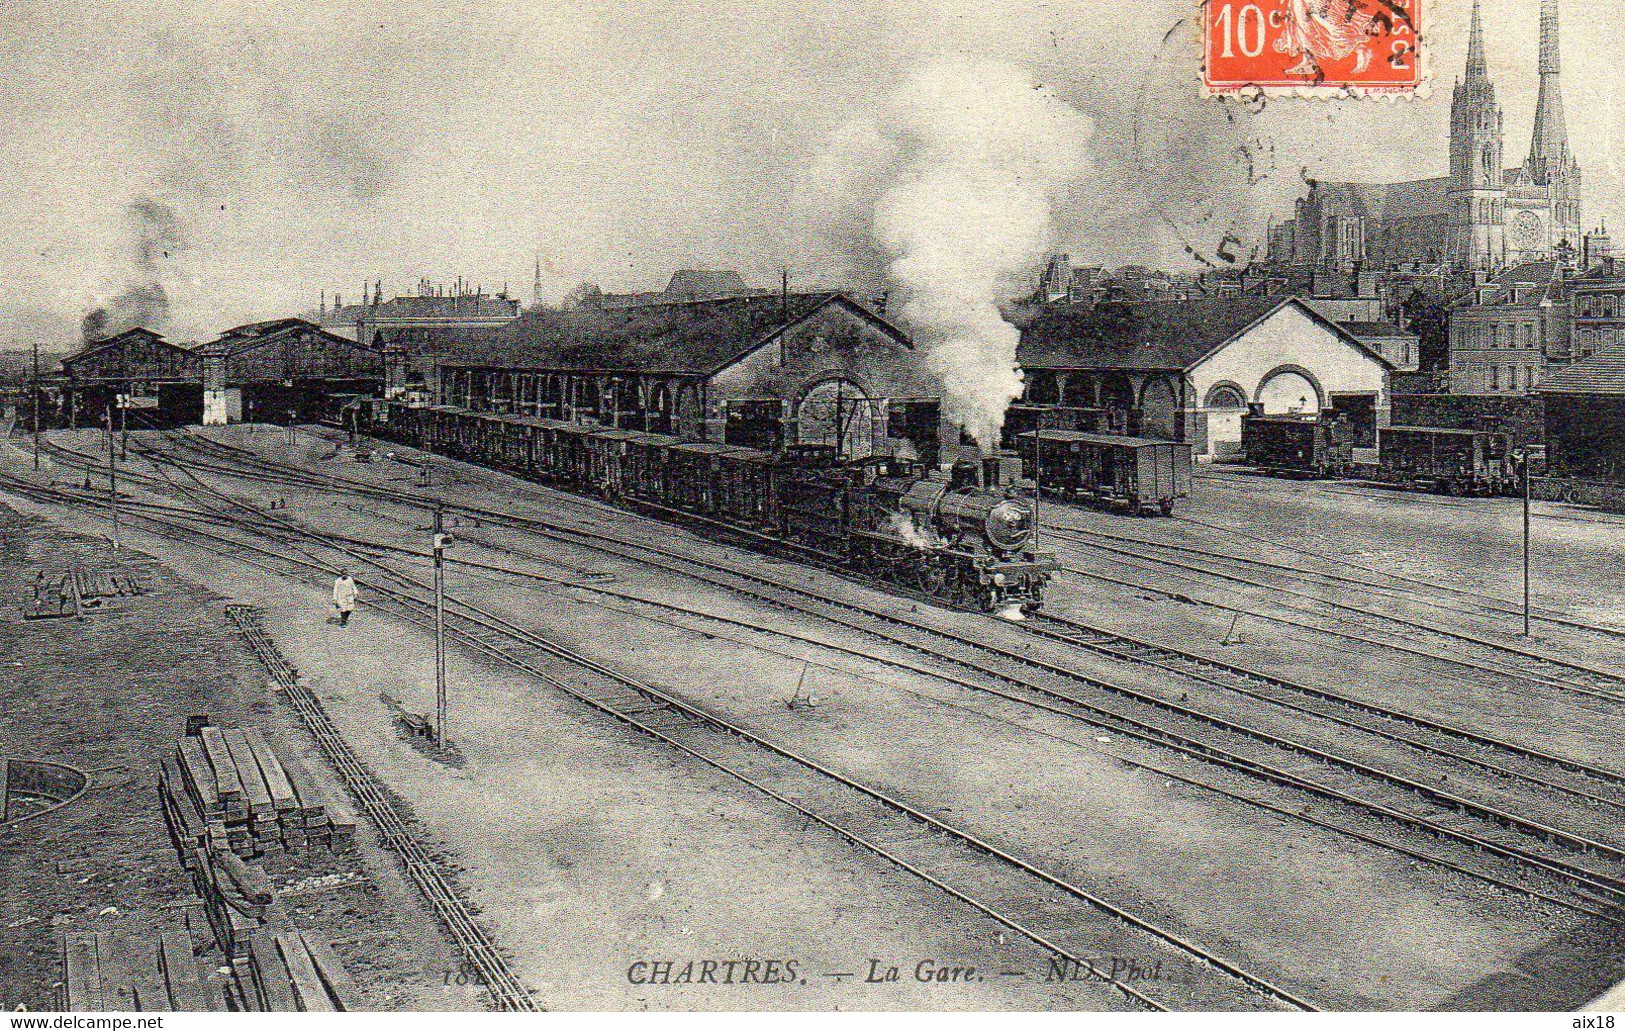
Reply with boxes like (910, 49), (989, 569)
(3, 448), (1315, 1010)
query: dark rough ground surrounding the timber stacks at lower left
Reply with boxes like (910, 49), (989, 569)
(0, 507), (483, 1010)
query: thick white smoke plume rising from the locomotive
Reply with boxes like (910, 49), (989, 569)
(801, 57), (1094, 446)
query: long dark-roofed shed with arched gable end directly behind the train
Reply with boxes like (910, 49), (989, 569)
(377, 293), (959, 460)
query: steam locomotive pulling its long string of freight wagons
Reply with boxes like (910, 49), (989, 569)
(372, 402), (1056, 618)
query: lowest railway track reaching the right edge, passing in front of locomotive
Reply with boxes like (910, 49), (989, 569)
(60, 429), (1620, 904)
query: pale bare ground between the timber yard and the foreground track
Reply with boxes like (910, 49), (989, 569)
(0, 429), (1123, 1010)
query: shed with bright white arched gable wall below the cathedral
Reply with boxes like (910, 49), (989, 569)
(1019, 298), (1396, 459)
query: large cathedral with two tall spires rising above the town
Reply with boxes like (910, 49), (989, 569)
(1269, 0), (1581, 272)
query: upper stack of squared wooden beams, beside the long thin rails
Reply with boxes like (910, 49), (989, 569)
(158, 725), (356, 867)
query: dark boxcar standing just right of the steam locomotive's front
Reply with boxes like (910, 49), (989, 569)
(1021, 429), (1193, 516)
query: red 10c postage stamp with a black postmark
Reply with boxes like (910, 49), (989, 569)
(1203, 0), (1424, 94)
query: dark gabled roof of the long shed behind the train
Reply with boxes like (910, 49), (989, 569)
(413, 293), (912, 376)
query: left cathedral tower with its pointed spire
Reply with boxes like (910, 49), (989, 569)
(1446, 0), (1508, 268)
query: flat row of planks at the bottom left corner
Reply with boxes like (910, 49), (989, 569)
(59, 932), (226, 1013)
